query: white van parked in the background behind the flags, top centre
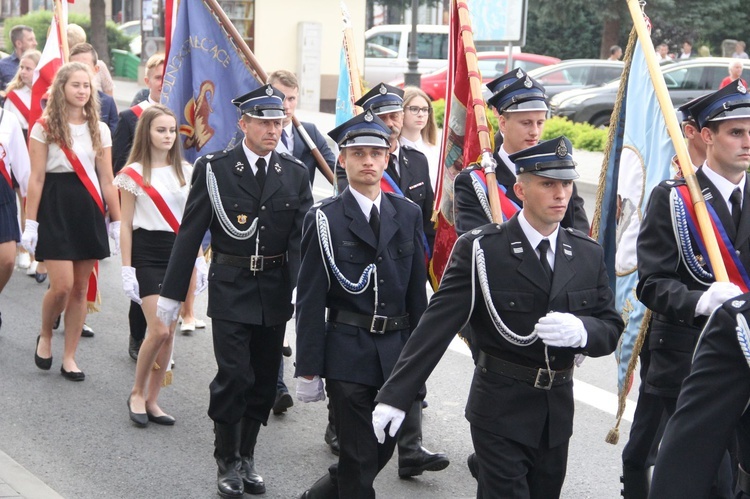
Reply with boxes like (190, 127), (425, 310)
(364, 24), (449, 87)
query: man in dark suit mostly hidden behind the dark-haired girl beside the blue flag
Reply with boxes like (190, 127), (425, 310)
(112, 54), (164, 360)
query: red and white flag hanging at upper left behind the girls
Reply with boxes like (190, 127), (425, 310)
(29, 0), (68, 128)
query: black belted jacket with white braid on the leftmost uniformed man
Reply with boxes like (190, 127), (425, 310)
(161, 144), (312, 326)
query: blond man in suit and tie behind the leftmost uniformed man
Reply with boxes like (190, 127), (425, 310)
(268, 69), (338, 418)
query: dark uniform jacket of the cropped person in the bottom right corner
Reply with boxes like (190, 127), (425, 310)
(649, 293), (750, 499)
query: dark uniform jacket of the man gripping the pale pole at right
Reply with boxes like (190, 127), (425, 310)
(636, 169), (750, 397)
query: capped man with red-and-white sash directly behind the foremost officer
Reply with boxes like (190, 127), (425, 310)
(454, 69), (589, 235)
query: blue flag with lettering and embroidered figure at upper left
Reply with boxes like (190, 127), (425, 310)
(161, 2), (259, 162)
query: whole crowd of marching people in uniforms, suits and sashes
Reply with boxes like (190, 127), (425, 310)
(7, 17), (750, 499)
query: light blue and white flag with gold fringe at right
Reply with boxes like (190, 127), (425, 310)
(599, 42), (677, 392)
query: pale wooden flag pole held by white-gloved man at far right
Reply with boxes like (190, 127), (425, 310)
(627, 0), (729, 282)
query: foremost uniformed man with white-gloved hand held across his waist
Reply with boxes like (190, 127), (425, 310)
(372, 137), (623, 499)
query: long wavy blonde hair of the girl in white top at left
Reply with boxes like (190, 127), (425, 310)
(42, 62), (102, 156)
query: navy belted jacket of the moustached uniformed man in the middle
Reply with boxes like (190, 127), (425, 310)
(295, 188), (427, 388)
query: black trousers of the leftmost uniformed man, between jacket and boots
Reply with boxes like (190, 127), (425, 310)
(208, 318), (286, 424)
